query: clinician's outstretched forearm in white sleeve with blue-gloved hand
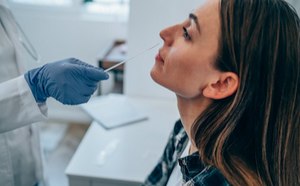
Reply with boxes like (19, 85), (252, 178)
(0, 58), (109, 133)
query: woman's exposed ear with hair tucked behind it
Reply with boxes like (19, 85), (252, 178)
(203, 72), (239, 99)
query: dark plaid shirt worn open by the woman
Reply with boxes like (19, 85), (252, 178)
(143, 120), (229, 186)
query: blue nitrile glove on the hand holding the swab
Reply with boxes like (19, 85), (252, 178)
(24, 58), (109, 105)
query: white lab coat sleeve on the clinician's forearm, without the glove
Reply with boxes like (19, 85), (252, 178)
(0, 76), (47, 133)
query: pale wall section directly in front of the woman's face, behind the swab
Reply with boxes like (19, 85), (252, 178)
(124, 0), (202, 99)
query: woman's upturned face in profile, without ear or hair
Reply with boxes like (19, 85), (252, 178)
(151, 0), (220, 98)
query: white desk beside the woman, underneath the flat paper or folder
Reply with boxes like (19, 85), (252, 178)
(66, 97), (179, 186)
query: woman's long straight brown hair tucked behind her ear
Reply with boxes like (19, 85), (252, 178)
(192, 0), (300, 186)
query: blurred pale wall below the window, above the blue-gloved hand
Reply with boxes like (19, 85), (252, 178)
(10, 4), (127, 67)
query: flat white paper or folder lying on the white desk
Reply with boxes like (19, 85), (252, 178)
(81, 94), (147, 129)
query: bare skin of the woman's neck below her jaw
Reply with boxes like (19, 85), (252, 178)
(177, 95), (211, 154)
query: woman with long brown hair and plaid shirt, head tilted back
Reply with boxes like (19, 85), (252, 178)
(144, 0), (300, 186)
